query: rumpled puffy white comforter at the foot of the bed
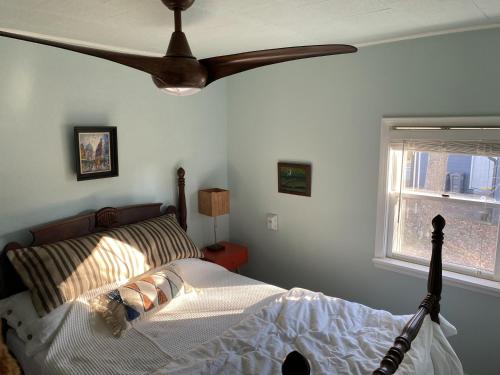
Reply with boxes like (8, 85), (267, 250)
(155, 288), (463, 375)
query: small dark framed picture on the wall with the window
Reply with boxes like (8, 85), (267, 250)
(278, 163), (311, 197)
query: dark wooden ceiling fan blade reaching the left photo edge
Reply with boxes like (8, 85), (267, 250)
(0, 30), (163, 75)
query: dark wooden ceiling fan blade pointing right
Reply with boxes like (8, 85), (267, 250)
(200, 44), (358, 85)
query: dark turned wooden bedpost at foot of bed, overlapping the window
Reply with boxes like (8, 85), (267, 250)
(373, 215), (446, 375)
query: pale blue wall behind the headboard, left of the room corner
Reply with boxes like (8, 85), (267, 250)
(0, 38), (227, 253)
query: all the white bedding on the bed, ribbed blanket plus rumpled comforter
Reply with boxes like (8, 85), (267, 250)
(36, 259), (462, 375)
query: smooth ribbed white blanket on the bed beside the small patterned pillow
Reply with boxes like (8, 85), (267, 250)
(41, 259), (285, 375)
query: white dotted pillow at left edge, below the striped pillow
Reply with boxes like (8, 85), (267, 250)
(0, 291), (70, 356)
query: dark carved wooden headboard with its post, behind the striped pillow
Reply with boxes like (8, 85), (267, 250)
(0, 168), (187, 299)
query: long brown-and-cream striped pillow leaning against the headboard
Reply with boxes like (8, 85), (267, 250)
(7, 215), (202, 316)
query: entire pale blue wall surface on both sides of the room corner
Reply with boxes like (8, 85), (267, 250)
(0, 26), (500, 375)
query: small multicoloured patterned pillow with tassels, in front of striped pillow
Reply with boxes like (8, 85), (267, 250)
(90, 266), (184, 337)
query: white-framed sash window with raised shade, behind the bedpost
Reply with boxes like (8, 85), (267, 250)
(374, 117), (500, 295)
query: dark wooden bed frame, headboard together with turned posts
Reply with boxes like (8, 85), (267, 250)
(0, 168), (445, 375)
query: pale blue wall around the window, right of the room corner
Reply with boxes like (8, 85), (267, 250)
(228, 29), (500, 375)
